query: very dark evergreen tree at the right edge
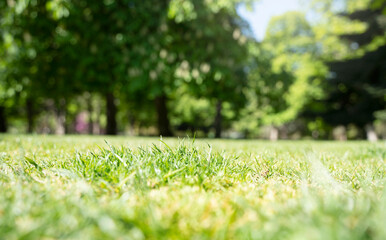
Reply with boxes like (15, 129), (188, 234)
(319, 1), (386, 140)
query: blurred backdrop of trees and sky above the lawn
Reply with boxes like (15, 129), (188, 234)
(0, 0), (386, 141)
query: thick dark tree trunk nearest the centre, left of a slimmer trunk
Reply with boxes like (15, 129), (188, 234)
(155, 95), (173, 137)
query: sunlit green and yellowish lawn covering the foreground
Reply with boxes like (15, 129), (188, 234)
(0, 135), (386, 240)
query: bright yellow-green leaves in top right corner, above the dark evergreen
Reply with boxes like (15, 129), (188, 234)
(313, 0), (386, 61)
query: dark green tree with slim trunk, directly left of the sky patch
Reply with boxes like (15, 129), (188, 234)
(169, 1), (248, 137)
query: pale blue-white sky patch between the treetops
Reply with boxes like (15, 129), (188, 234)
(238, 0), (304, 40)
